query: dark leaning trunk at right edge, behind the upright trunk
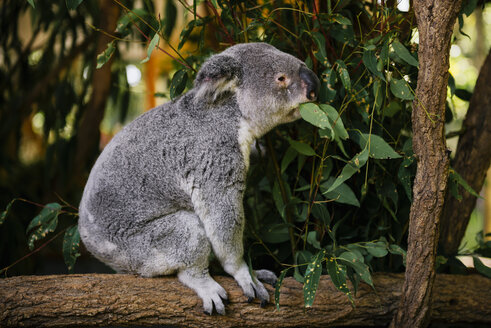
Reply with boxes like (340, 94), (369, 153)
(440, 51), (491, 255)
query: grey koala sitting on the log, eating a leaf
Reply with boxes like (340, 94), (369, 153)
(78, 43), (319, 314)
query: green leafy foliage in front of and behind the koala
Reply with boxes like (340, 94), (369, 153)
(0, 0), (490, 308)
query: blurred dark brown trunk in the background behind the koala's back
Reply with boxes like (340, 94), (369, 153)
(72, 0), (120, 181)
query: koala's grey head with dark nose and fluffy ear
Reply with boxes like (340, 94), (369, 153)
(195, 43), (320, 137)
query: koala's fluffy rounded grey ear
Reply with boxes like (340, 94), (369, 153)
(194, 54), (242, 103)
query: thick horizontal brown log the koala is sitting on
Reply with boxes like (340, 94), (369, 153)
(0, 274), (491, 327)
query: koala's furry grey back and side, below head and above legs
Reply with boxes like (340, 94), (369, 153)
(79, 93), (245, 251)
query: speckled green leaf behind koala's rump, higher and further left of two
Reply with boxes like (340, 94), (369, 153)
(26, 203), (61, 250)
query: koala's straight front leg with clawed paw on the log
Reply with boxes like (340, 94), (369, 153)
(193, 188), (276, 306)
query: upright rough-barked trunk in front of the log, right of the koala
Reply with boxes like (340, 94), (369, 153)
(391, 0), (462, 328)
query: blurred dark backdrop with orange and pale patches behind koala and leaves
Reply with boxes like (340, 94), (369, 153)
(0, 0), (491, 276)
